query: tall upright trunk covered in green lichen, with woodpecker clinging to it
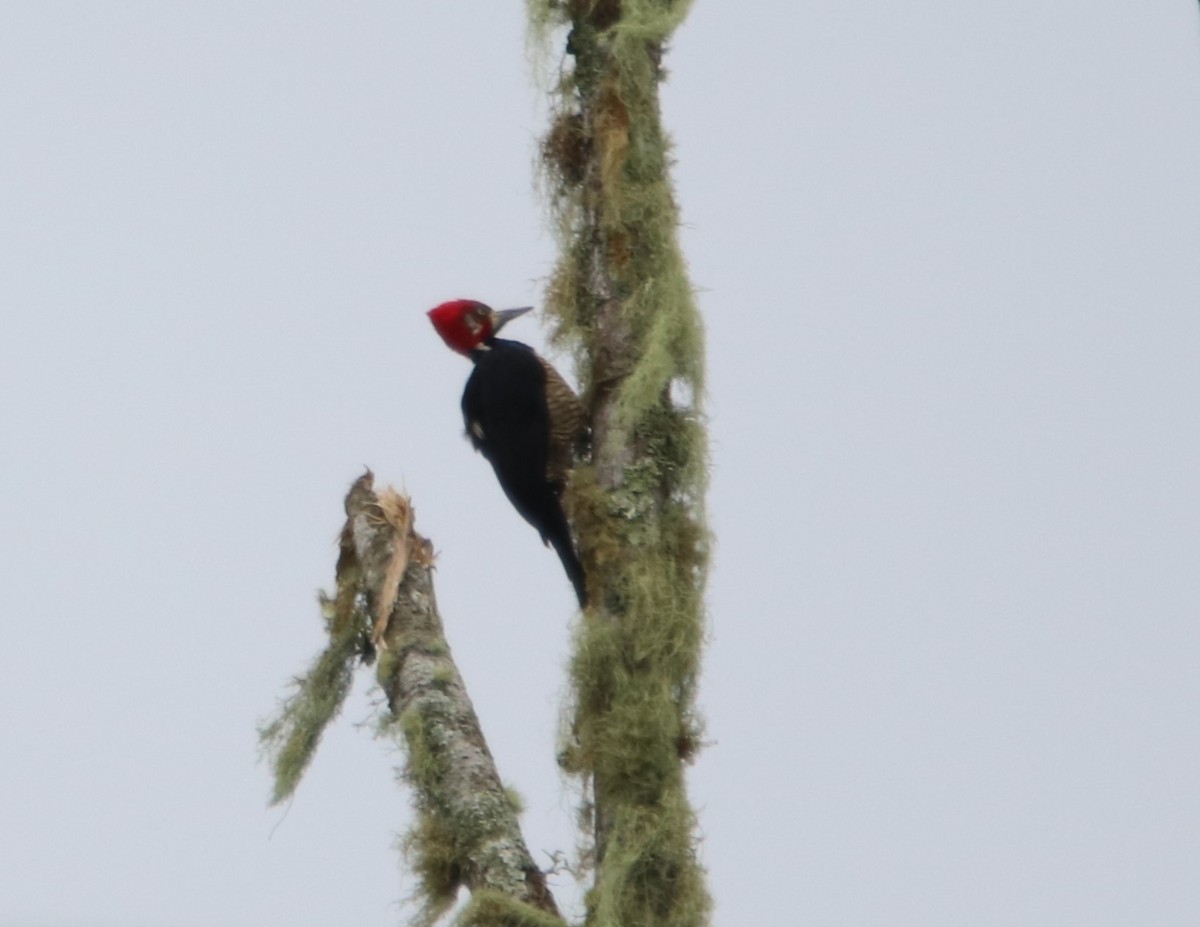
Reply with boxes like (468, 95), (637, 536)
(530, 0), (709, 927)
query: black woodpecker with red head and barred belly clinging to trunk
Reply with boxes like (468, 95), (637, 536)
(428, 299), (587, 608)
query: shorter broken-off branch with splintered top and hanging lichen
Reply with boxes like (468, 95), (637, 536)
(262, 471), (563, 927)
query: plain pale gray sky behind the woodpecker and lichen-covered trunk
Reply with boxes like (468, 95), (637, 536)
(0, 0), (1200, 927)
